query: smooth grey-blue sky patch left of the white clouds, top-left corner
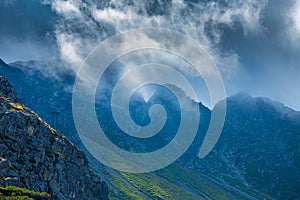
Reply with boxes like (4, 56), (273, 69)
(0, 0), (56, 62)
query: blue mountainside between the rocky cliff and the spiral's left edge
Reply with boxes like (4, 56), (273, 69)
(0, 59), (78, 144)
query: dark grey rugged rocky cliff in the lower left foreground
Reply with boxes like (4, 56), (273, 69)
(0, 77), (108, 199)
